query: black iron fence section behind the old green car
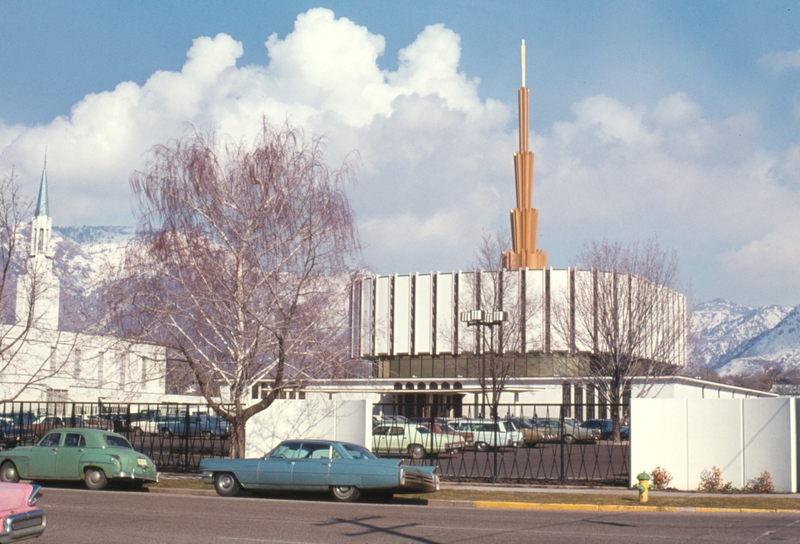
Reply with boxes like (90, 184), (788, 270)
(0, 401), (230, 472)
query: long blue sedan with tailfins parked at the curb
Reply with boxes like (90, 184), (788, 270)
(200, 440), (439, 502)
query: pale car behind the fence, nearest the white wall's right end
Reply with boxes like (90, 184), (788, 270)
(372, 423), (464, 459)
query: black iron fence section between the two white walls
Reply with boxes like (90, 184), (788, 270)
(372, 403), (630, 485)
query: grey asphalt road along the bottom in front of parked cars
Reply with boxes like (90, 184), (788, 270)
(35, 487), (800, 544)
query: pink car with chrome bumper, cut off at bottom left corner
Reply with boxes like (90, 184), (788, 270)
(0, 482), (47, 544)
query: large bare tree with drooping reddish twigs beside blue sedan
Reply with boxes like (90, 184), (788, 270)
(106, 120), (359, 457)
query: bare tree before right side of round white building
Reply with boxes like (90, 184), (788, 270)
(551, 240), (687, 440)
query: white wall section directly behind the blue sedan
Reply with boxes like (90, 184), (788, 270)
(245, 396), (372, 457)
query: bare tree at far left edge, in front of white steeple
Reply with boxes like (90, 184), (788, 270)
(0, 170), (80, 401)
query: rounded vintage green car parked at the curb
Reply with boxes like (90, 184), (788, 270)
(0, 429), (158, 489)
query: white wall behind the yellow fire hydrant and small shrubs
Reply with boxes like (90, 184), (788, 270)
(631, 397), (800, 493)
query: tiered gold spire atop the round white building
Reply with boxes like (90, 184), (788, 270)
(503, 40), (547, 270)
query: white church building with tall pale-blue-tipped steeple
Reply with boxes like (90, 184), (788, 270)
(0, 164), (166, 402)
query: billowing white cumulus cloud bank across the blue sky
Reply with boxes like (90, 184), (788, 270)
(0, 8), (800, 304)
